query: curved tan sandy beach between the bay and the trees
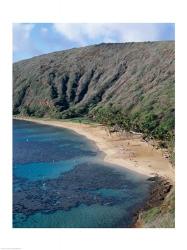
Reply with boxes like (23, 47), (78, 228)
(14, 117), (175, 183)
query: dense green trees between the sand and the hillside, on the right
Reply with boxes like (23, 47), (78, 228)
(89, 105), (174, 145)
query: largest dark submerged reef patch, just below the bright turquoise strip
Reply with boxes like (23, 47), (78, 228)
(13, 164), (138, 215)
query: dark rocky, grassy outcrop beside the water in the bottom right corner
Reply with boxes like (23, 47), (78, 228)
(132, 176), (175, 228)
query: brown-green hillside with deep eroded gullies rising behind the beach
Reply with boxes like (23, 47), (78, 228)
(13, 42), (175, 125)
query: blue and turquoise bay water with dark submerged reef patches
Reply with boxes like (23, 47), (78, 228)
(13, 120), (149, 228)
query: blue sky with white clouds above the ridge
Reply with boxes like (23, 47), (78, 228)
(13, 23), (175, 62)
